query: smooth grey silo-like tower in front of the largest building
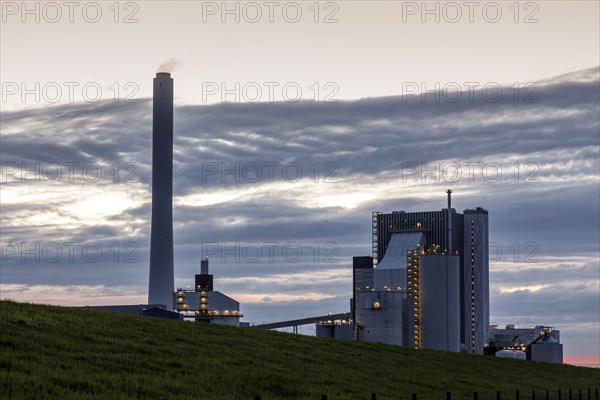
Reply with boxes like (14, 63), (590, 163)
(419, 254), (460, 352)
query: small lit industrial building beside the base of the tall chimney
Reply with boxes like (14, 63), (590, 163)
(173, 257), (243, 326)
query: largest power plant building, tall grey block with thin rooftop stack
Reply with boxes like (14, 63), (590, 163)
(352, 190), (489, 354)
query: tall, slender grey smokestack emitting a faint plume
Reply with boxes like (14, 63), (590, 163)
(148, 72), (174, 310)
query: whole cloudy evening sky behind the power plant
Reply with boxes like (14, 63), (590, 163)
(0, 1), (600, 364)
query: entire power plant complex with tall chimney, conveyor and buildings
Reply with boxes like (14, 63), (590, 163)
(92, 72), (562, 363)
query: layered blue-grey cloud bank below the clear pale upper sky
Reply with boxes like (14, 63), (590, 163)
(1, 68), (600, 362)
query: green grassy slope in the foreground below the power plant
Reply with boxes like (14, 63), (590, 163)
(0, 301), (600, 400)
